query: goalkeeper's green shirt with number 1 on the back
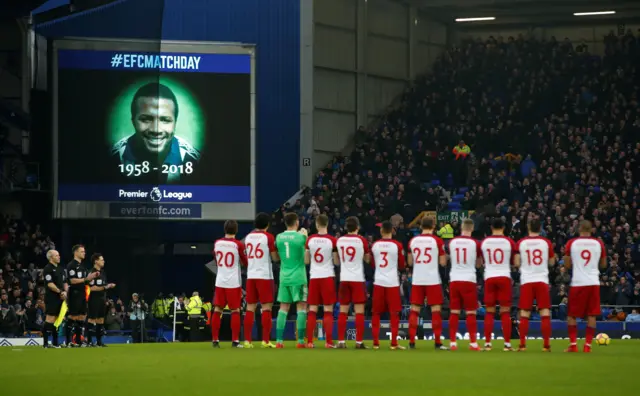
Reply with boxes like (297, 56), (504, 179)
(276, 231), (307, 286)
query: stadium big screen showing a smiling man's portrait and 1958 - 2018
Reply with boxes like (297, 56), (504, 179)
(53, 40), (255, 220)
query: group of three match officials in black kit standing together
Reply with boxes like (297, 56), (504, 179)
(42, 245), (116, 348)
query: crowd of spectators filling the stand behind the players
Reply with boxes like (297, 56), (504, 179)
(272, 31), (640, 318)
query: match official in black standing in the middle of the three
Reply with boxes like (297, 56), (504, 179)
(66, 245), (100, 348)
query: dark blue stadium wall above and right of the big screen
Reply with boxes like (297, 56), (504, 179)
(36, 0), (300, 240)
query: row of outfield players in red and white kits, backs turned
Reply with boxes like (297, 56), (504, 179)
(214, 213), (606, 352)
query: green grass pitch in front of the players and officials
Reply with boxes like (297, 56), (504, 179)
(0, 340), (640, 396)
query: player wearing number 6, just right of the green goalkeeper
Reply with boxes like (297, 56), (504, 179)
(304, 214), (339, 349)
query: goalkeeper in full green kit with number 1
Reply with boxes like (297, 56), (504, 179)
(276, 213), (307, 349)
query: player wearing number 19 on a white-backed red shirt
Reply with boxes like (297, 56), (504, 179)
(337, 216), (371, 349)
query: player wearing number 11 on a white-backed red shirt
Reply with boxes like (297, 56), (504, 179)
(449, 219), (482, 351)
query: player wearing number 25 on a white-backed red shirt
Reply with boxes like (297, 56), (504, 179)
(407, 217), (447, 350)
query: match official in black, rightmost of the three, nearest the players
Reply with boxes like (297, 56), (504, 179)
(87, 253), (116, 347)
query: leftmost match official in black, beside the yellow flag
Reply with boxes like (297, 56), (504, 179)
(42, 250), (67, 348)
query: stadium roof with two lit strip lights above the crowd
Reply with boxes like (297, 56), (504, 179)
(395, 0), (640, 25)
